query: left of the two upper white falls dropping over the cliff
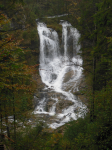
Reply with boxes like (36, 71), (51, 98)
(37, 23), (59, 64)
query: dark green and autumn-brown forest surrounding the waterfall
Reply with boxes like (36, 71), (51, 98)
(0, 0), (112, 150)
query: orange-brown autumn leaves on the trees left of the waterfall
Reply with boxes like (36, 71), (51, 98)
(0, 11), (38, 116)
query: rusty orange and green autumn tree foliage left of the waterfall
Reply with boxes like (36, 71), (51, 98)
(0, 11), (37, 139)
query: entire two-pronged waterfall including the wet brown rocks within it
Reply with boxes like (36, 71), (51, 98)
(33, 20), (87, 128)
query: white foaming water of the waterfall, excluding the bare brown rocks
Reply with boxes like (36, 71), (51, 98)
(34, 21), (86, 128)
